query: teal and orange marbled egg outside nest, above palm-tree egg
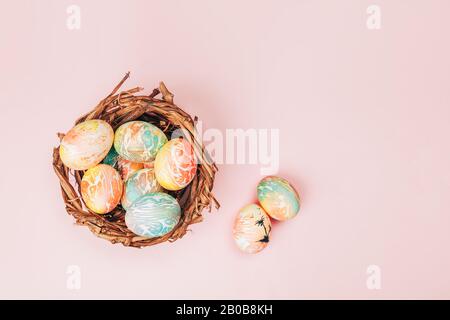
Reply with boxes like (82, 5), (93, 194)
(257, 176), (300, 221)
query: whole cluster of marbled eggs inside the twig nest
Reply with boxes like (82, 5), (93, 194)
(60, 120), (197, 237)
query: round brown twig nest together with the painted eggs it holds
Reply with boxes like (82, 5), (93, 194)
(53, 74), (219, 247)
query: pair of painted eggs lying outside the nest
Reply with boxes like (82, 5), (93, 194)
(233, 176), (300, 253)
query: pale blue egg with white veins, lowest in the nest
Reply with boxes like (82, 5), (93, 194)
(125, 192), (181, 238)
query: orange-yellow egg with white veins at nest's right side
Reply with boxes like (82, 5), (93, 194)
(155, 138), (197, 190)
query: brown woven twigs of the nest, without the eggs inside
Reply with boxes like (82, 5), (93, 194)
(53, 73), (219, 248)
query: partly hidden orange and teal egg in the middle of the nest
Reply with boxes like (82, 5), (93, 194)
(122, 169), (163, 210)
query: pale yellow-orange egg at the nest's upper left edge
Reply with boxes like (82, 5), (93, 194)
(59, 120), (114, 170)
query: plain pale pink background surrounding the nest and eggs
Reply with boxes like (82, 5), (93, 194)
(0, 0), (450, 299)
